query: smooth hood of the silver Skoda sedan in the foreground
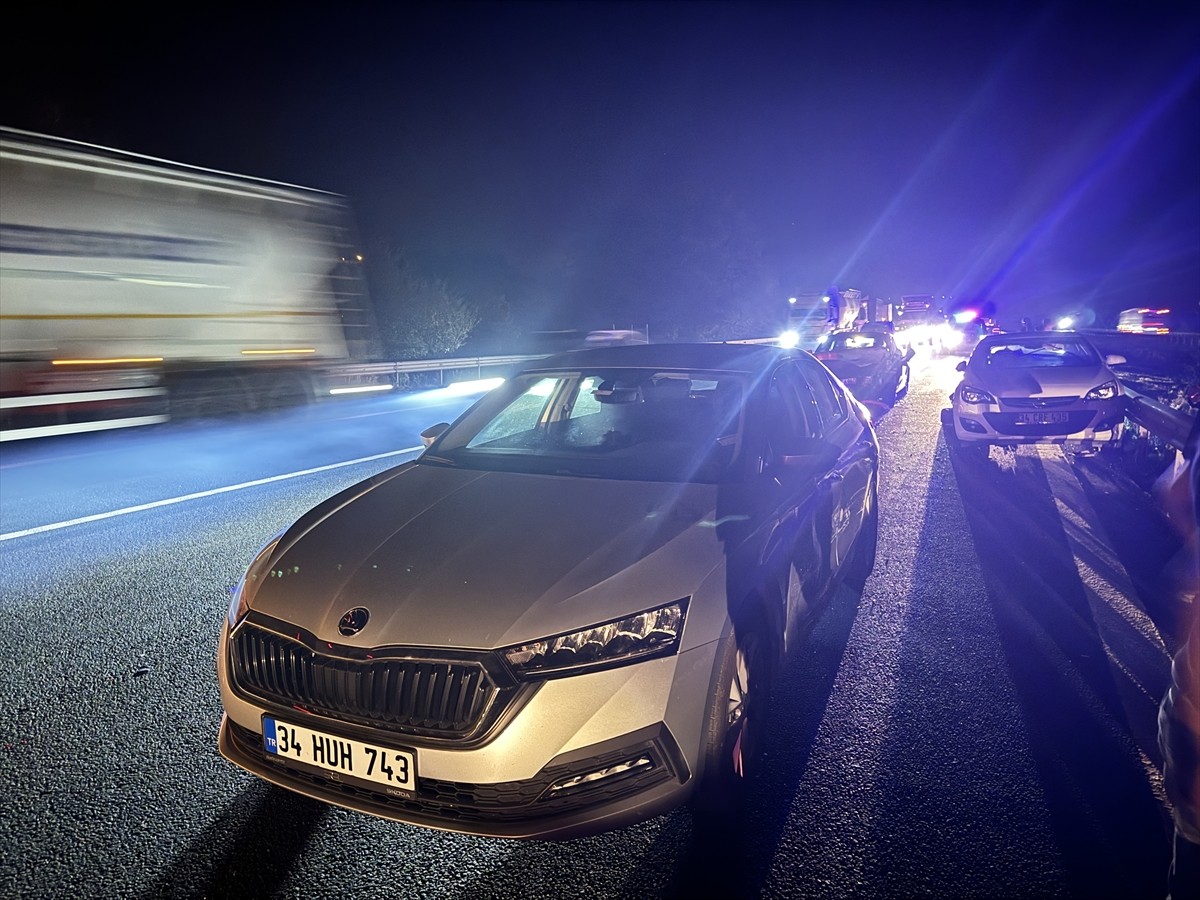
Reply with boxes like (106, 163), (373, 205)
(251, 463), (724, 649)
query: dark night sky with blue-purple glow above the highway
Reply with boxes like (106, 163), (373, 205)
(0, 0), (1200, 332)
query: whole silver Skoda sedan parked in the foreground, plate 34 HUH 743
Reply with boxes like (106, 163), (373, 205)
(217, 343), (878, 838)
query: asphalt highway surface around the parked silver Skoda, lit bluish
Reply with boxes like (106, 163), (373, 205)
(0, 360), (1181, 899)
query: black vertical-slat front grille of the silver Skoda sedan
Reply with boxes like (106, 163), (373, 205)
(230, 623), (502, 739)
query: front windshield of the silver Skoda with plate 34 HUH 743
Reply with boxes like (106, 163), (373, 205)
(424, 368), (744, 482)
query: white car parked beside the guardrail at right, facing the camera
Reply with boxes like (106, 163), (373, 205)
(943, 331), (1126, 456)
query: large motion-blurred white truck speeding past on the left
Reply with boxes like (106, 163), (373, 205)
(0, 128), (388, 440)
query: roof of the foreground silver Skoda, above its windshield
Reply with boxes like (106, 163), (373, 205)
(521, 342), (809, 373)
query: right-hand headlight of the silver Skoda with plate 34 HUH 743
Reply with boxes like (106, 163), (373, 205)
(504, 600), (688, 677)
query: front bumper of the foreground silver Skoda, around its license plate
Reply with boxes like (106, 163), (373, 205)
(217, 636), (716, 839)
